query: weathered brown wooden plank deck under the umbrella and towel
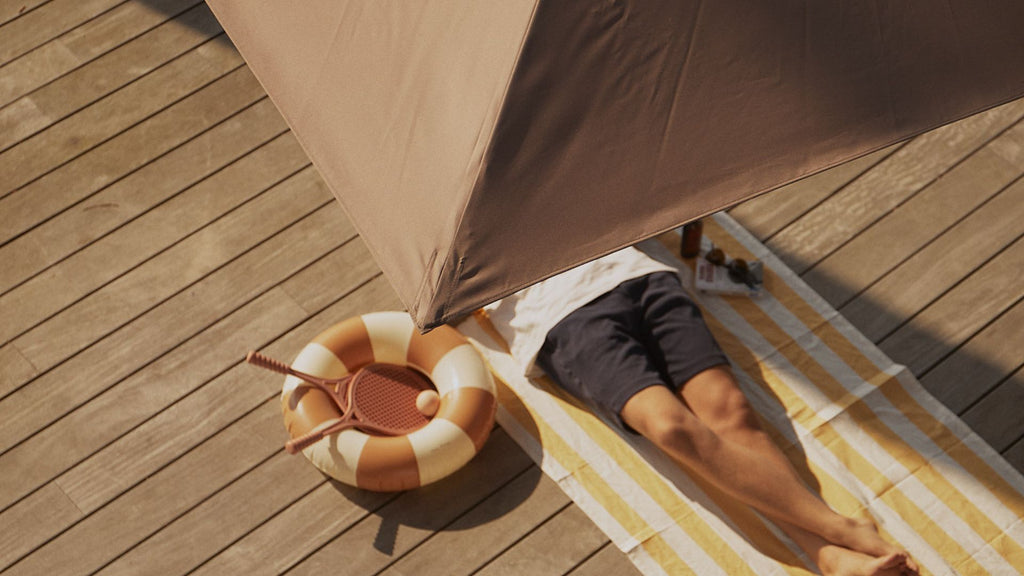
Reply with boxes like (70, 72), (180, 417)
(0, 0), (1024, 575)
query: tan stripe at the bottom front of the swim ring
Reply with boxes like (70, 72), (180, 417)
(355, 436), (420, 492)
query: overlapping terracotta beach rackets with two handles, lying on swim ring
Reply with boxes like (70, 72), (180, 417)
(246, 352), (433, 454)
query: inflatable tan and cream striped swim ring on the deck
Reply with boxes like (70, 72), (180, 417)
(281, 312), (498, 492)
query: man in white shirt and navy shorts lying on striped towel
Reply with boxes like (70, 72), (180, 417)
(485, 241), (918, 575)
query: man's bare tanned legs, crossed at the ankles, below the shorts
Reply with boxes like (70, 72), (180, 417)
(622, 367), (913, 569)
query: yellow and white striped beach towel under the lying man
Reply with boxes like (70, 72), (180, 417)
(459, 214), (1024, 576)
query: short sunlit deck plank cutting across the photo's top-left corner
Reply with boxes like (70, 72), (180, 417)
(0, 0), (123, 65)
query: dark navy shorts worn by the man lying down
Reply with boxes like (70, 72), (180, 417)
(537, 272), (728, 429)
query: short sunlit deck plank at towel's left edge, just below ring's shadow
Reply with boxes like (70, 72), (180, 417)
(477, 506), (608, 576)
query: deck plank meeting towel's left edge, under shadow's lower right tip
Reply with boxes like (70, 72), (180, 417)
(381, 466), (569, 576)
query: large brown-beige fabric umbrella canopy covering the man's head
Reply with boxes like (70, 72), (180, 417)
(208, 0), (1024, 328)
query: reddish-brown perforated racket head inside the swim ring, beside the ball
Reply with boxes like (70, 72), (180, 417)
(347, 362), (434, 436)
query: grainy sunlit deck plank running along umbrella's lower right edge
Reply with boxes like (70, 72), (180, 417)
(767, 100), (1024, 274)
